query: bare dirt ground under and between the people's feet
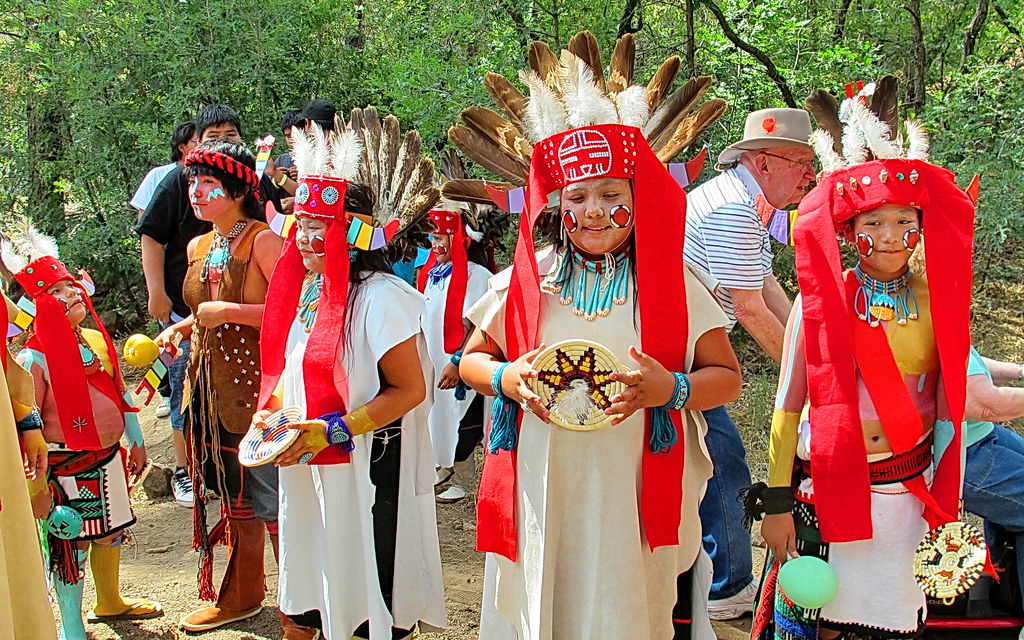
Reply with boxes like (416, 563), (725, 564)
(54, 407), (1017, 640)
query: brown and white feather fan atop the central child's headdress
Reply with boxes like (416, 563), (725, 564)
(444, 31), (726, 202)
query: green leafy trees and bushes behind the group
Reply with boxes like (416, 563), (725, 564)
(0, 0), (1024, 330)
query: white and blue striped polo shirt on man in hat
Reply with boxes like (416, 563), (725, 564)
(683, 165), (774, 331)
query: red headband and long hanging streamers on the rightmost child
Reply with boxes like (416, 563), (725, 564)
(794, 160), (974, 542)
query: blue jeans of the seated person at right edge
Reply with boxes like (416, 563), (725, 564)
(964, 425), (1024, 590)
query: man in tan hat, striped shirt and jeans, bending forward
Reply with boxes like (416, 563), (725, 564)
(684, 109), (814, 620)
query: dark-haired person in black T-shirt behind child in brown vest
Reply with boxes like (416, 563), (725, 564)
(135, 104), (281, 508)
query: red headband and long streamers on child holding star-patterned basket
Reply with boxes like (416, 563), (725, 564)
(477, 125), (689, 561)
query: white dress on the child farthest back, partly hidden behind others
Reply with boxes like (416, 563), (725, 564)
(423, 262), (492, 467)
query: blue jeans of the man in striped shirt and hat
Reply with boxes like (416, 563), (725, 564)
(700, 407), (754, 600)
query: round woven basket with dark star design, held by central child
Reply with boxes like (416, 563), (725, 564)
(530, 340), (627, 431)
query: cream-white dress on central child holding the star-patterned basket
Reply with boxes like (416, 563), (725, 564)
(469, 249), (727, 640)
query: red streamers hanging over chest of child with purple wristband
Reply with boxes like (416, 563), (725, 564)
(259, 184), (349, 464)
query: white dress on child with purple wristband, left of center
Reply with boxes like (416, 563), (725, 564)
(278, 273), (445, 640)
